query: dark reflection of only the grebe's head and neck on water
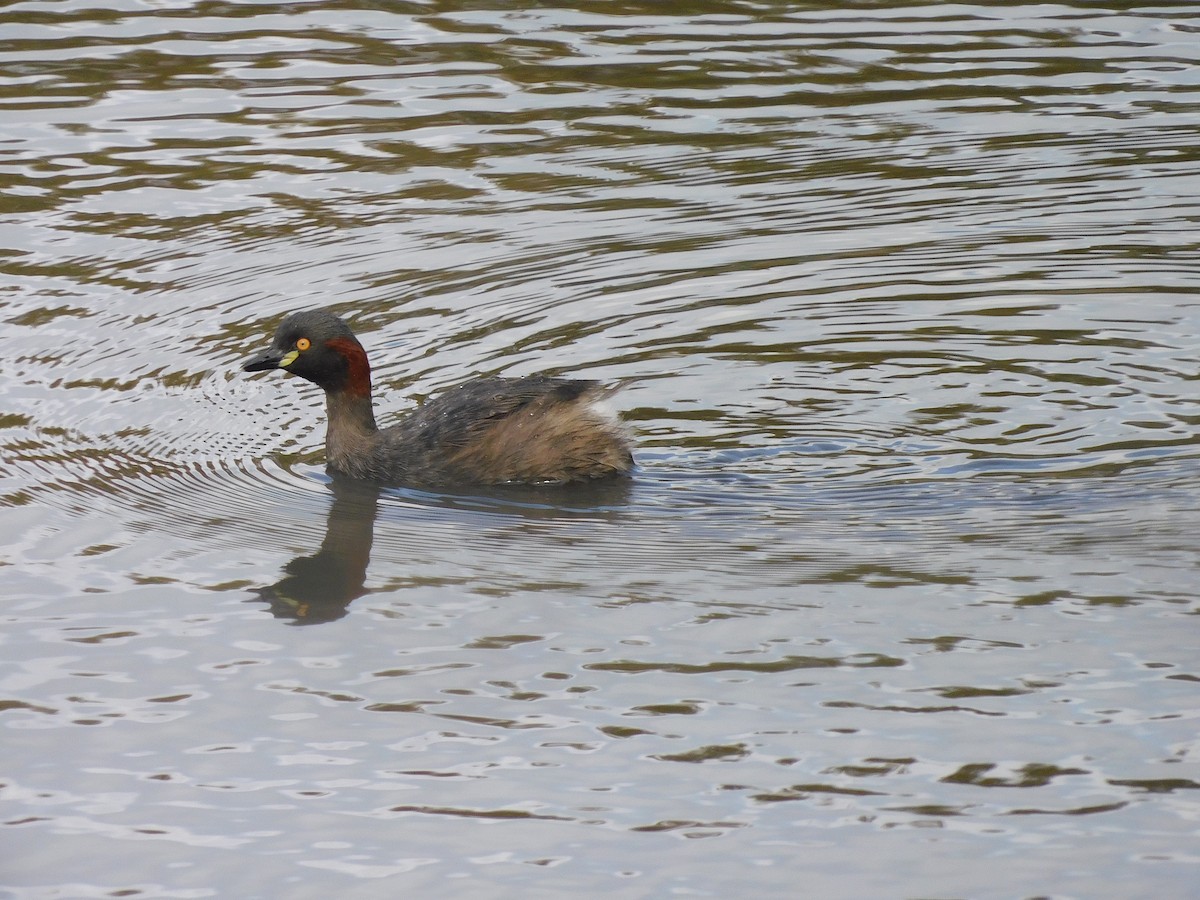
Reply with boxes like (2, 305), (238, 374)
(254, 480), (379, 625)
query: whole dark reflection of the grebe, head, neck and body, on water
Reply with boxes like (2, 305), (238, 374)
(254, 478), (631, 625)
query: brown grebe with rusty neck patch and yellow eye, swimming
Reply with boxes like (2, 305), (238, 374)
(242, 310), (634, 486)
